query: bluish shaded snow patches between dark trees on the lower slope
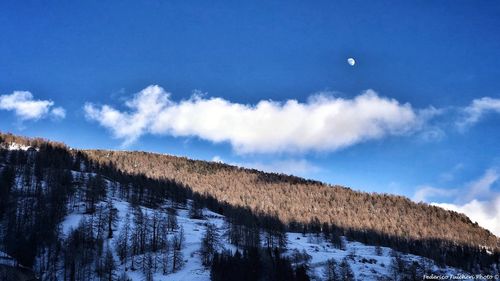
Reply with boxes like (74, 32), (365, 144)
(55, 171), (472, 281)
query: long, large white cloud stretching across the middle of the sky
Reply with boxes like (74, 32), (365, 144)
(84, 86), (429, 153)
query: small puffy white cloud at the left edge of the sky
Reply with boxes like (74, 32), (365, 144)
(0, 91), (65, 121)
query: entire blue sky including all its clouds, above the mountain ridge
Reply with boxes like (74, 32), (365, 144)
(0, 0), (500, 234)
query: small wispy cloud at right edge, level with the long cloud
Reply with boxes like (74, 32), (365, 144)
(456, 97), (500, 130)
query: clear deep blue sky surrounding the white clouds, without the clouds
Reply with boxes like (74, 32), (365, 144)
(0, 0), (500, 219)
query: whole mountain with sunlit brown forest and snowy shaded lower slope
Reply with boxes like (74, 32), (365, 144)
(0, 134), (500, 280)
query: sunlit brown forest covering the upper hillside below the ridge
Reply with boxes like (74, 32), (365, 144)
(80, 150), (500, 250)
